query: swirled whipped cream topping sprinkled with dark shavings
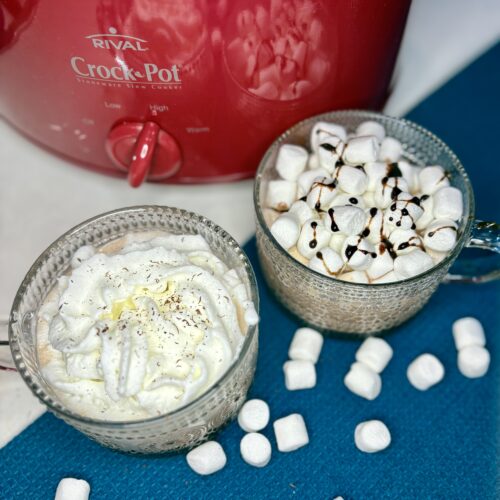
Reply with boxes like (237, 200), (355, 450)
(37, 233), (258, 420)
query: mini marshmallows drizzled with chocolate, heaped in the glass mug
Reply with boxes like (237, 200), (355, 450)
(264, 117), (463, 283)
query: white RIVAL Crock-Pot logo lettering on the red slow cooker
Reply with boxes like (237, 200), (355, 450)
(70, 28), (182, 89)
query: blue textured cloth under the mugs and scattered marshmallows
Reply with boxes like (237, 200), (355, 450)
(0, 46), (500, 500)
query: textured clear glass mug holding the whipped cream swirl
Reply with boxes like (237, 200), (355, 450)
(0, 206), (259, 453)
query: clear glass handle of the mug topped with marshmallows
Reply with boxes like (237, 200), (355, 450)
(444, 220), (500, 283)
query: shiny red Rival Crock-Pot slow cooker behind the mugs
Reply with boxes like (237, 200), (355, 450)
(0, 0), (410, 186)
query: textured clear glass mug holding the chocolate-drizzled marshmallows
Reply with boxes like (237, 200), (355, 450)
(254, 111), (500, 334)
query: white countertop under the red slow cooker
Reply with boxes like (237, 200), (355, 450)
(0, 0), (500, 447)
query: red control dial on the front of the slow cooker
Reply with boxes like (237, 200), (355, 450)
(106, 122), (181, 187)
